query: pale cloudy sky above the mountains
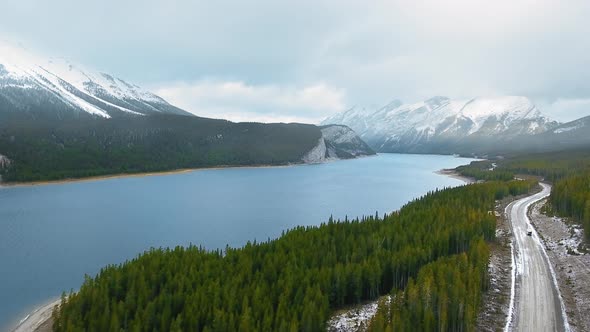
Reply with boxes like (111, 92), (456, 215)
(0, 0), (590, 123)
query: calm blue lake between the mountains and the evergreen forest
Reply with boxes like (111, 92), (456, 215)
(0, 154), (471, 330)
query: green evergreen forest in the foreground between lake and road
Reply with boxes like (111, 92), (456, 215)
(54, 181), (534, 331)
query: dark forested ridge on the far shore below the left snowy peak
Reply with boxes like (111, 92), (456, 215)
(0, 115), (322, 182)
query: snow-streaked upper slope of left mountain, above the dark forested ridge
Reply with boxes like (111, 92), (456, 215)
(0, 41), (190, 118)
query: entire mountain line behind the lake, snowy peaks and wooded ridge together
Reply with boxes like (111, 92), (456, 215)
(0, 41), (590, 181)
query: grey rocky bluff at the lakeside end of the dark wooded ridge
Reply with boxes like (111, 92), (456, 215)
(302, 125), (375, 163)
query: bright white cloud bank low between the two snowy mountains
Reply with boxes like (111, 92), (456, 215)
(155, 80), (346, 123)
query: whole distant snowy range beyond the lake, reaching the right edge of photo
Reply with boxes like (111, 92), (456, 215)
(322, 96), (589, 155)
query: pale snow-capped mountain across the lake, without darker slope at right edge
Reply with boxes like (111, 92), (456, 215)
(322, 96), (558, 153)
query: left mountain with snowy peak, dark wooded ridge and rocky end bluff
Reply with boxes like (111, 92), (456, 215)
(0, 42), (375, 181)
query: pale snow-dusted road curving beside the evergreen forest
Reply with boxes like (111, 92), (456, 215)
(505, 183), (569, 331)
